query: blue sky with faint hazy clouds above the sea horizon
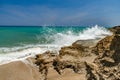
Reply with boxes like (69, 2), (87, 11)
(0, 0), (120, 26)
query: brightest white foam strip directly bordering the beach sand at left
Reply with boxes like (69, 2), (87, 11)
(0, 45), (59, 64)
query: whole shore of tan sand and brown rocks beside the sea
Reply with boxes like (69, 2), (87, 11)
(0, 26), (120, 80)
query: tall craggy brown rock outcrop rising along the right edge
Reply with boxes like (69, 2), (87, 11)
(90, 26), (120, 80)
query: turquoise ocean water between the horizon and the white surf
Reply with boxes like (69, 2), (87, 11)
(0, 26), (86, 47)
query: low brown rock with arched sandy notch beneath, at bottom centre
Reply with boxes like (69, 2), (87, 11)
(53, 59), (85, 75)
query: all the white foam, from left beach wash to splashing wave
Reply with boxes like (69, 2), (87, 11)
(0, 25), (112, 64)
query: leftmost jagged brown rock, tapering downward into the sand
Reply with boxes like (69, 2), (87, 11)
(35, 51), (57, 80)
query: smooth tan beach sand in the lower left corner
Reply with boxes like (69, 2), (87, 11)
(0, 61), (41, 80)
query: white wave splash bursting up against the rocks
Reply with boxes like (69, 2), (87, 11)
(50, 25), (112, 46)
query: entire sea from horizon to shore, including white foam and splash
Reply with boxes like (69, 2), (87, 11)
(0, 25), (111, 64)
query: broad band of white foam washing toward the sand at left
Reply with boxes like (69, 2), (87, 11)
(0, 45), (59, 65)
